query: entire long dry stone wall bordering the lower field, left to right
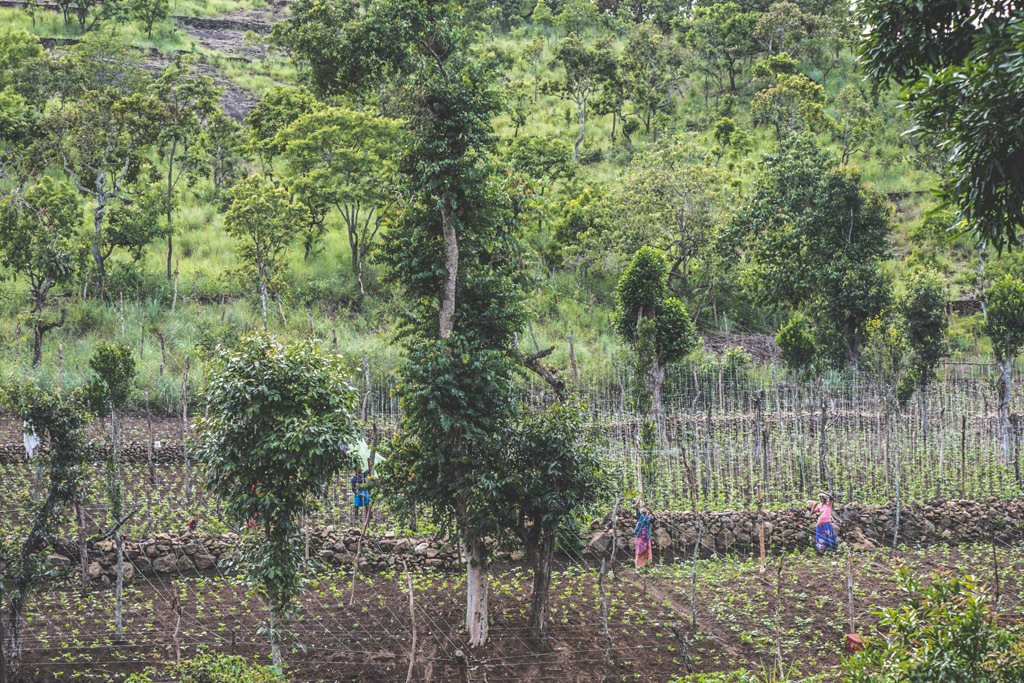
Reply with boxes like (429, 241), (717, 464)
(49, 499), (1024, 585)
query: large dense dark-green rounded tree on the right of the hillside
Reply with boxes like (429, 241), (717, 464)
(723, 136), (892, 368)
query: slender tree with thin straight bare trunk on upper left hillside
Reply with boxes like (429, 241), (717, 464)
(150, 54), (220, 280)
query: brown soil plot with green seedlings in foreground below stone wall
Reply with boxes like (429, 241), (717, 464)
(9, 544), (1024, 681)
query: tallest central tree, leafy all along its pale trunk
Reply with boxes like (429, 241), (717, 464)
(280, 0), (523, 646)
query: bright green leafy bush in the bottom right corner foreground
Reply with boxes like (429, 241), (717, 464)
(844, 566), (1024, 683)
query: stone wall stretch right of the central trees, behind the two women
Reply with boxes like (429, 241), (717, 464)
(586, 499), (1024, 556)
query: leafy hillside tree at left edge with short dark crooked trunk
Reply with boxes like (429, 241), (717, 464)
(0, 177), (86, 368)
